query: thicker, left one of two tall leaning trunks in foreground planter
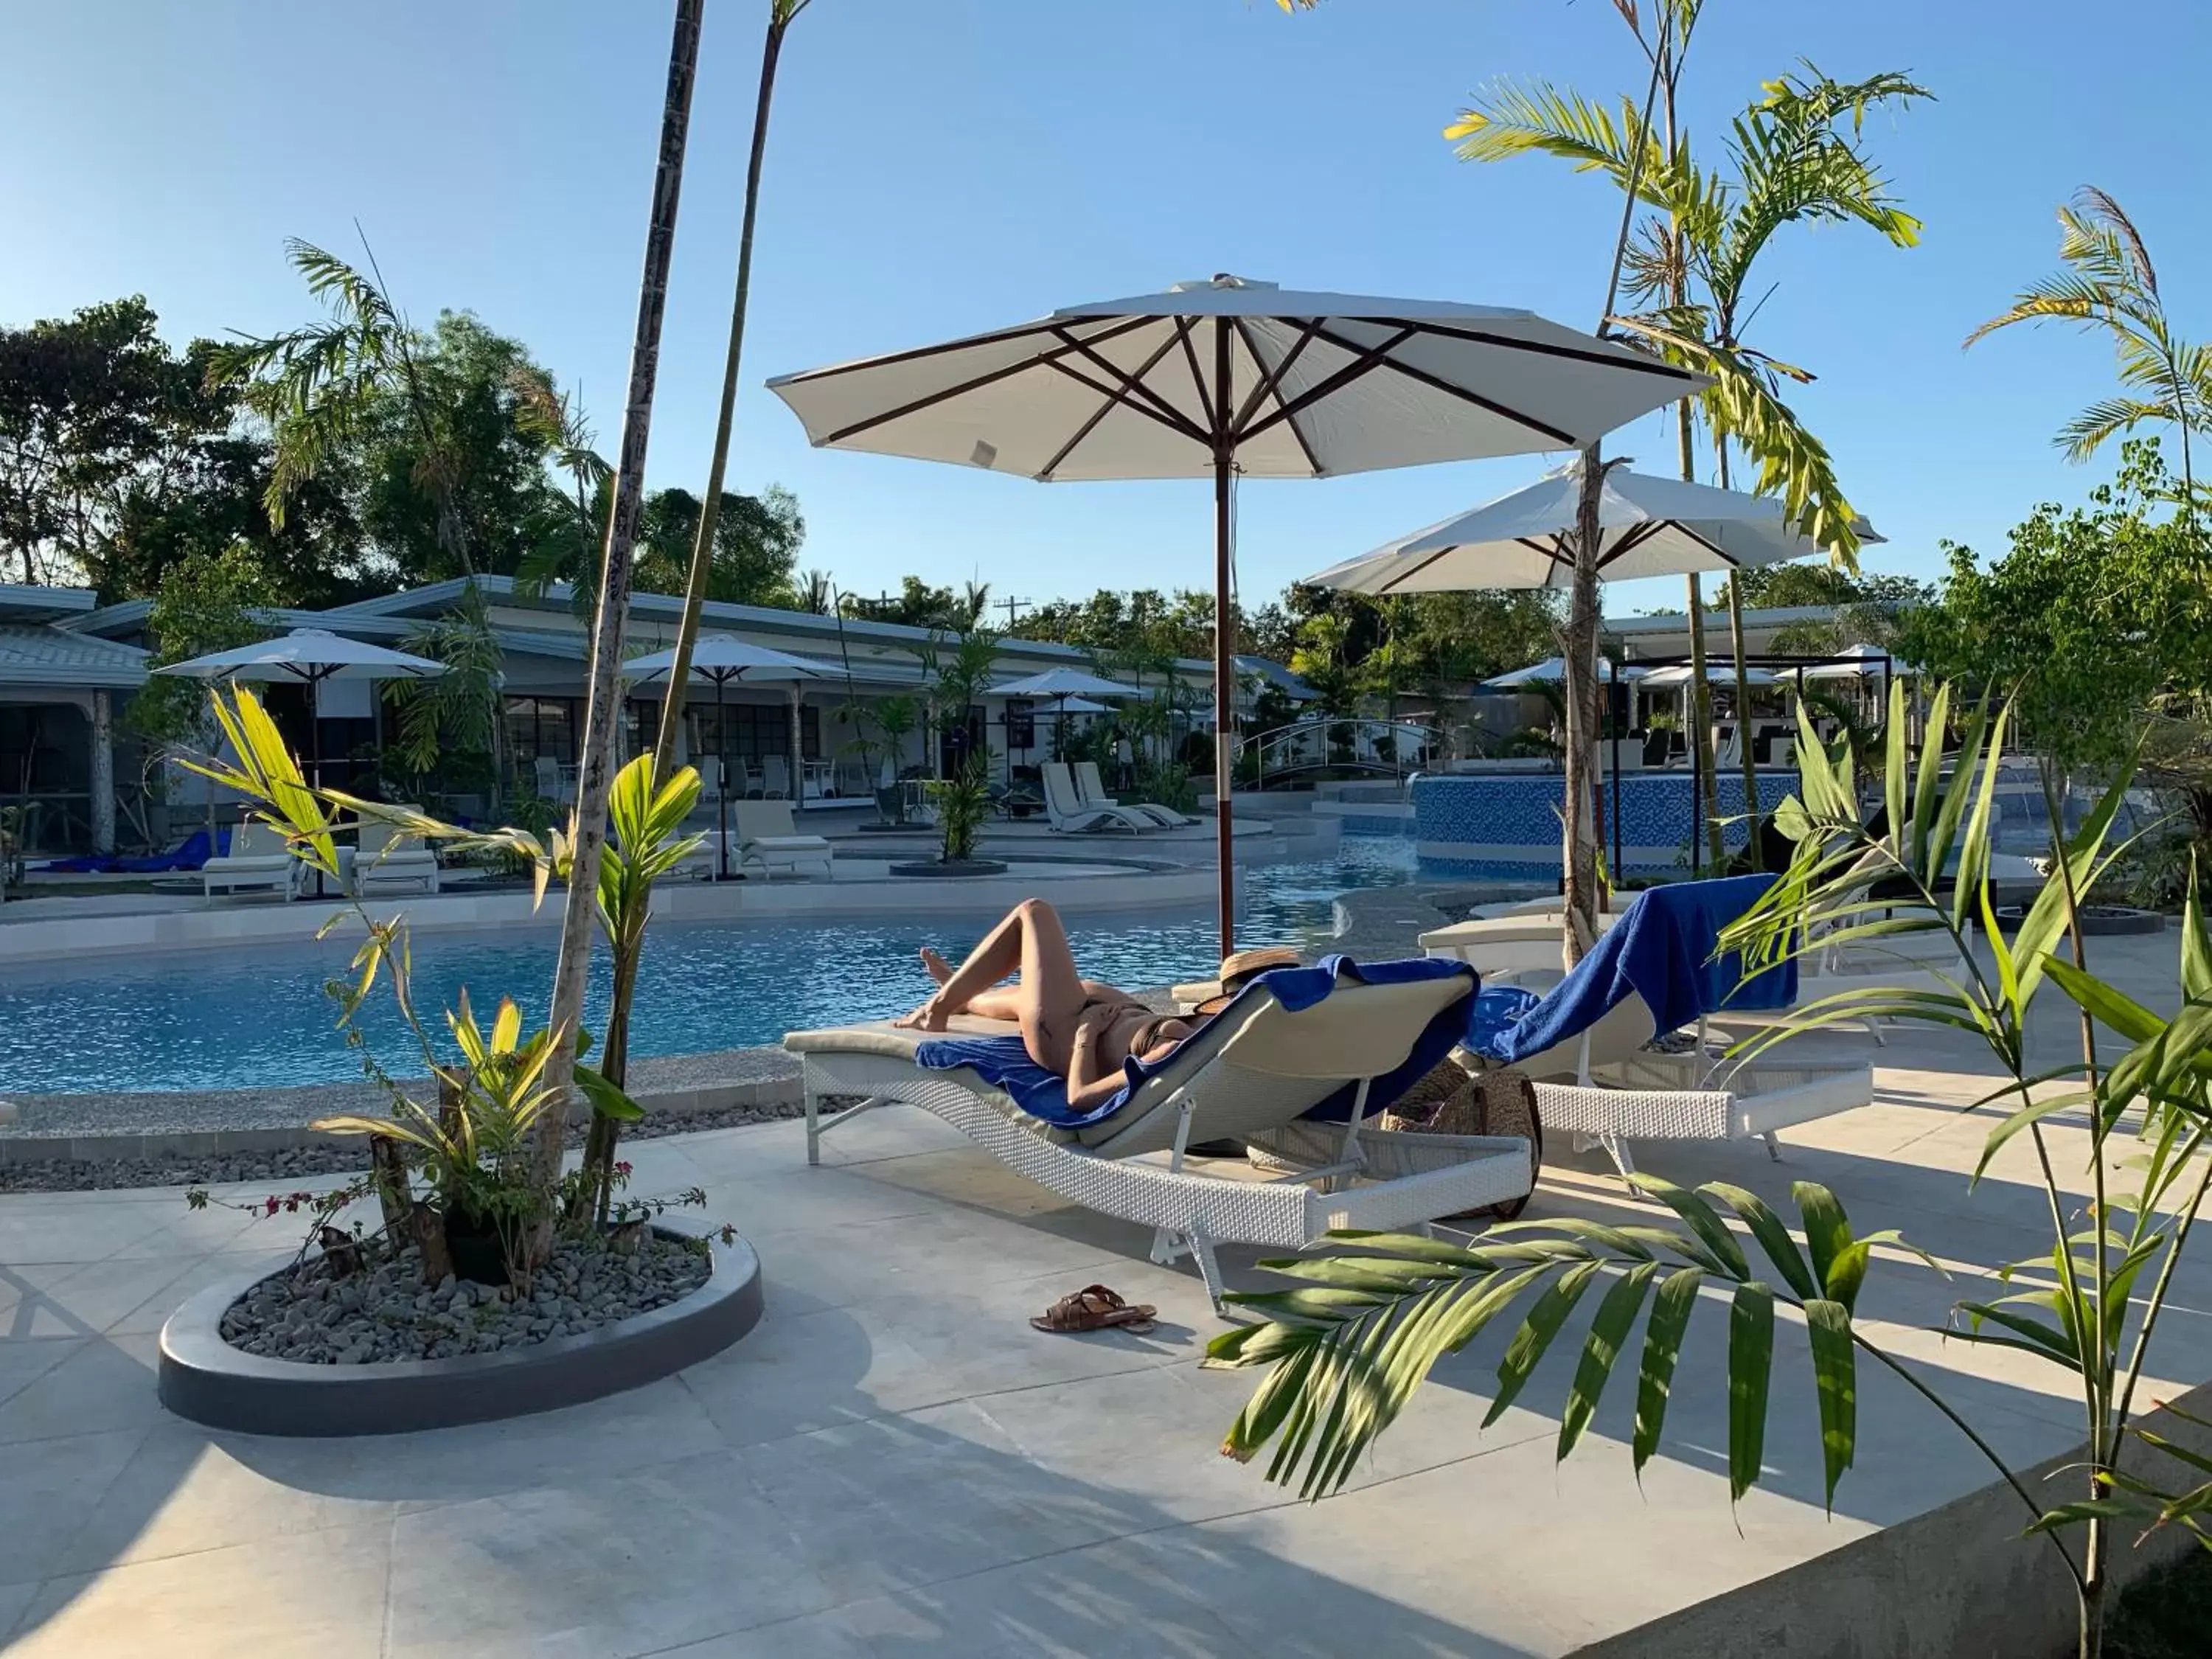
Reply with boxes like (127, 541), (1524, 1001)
(526, 0), (706, 1267)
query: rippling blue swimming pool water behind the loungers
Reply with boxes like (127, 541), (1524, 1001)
(0, 838), (1416, 1095)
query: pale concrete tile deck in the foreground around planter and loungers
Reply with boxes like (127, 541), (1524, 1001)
(0, 933), (2212, 1659)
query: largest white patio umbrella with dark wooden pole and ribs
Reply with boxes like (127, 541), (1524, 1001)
(768, 276), (1703, 956)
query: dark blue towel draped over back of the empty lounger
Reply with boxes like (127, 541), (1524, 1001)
(1467, 876), (1796, 1066)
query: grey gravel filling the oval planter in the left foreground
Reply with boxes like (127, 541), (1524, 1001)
(221, 1230), (712, 1365)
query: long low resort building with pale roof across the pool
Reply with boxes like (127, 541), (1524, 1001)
(21, 575), (1230, 854)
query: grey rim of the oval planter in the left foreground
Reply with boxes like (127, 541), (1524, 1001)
(159, 1221), (761, 1436)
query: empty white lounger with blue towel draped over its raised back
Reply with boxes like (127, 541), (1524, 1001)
(1469, 876), (1887, 1181)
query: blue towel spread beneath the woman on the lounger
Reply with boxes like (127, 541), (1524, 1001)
(914, 956), (1473, 1128)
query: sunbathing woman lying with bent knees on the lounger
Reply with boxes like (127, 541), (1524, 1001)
(898, 898), (1298, 1110)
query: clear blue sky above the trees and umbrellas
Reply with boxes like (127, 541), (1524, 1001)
(0, 0), (2212, 613)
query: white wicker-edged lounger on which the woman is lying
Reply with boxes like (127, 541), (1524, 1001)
(783, 964), (1533, 1312)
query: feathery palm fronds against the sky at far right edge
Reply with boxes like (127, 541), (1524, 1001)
(1966, 184), (2212, 502)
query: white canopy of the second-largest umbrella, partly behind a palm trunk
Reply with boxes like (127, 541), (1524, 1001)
(1303, 458), (1882, 595)
